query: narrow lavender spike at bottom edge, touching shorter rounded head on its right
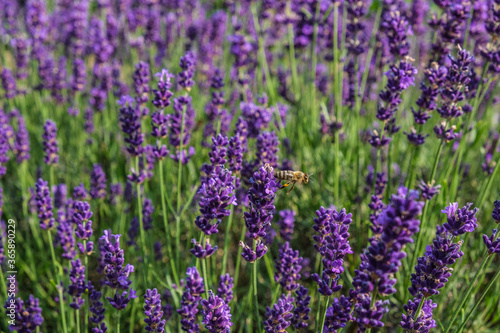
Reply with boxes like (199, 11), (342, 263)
(177, 267), (205, 332)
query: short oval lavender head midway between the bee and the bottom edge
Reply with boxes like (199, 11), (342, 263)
(274, 242), (303, 293)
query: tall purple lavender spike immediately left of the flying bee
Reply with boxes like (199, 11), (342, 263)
(240, 164), (278, 262)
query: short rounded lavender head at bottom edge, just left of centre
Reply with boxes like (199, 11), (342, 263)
(201, 290), (233, 333)
